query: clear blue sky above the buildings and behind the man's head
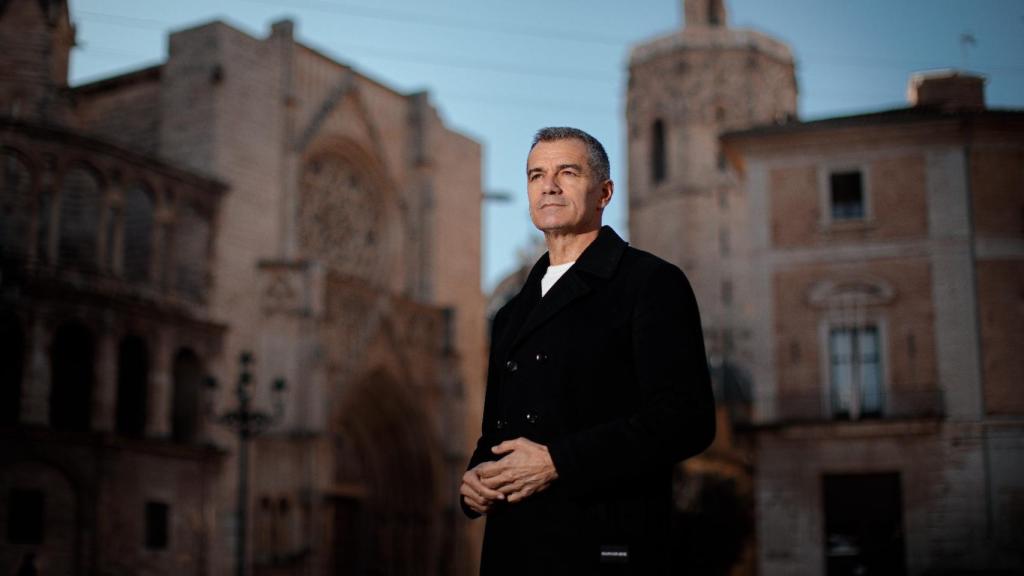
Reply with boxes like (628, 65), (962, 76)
(70, 0), (1024, 289)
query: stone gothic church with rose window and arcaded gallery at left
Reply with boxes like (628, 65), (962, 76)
(0, 0), (485, 574)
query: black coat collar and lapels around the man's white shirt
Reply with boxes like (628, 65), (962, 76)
(503, 225), (627, 346)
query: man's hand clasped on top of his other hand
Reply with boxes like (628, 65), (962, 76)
(474, 438), (558, 502)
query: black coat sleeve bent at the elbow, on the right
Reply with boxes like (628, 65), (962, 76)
(548, 263), (715, 489)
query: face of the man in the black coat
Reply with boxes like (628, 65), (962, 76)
(526, 139), (612, 234)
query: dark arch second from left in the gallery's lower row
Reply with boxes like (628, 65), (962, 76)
(50, 322), (96, 430)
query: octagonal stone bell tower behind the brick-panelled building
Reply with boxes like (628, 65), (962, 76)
(626, 0), (797, 362)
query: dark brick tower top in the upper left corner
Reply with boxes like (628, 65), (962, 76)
(0, 0), (75, 124)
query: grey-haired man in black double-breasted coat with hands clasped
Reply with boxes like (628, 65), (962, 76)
(461, 128), (715, 576)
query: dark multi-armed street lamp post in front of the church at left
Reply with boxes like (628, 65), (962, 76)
(207, 352), (285, 576)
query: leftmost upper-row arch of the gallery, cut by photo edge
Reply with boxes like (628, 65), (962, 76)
(0, 150), (32, 257)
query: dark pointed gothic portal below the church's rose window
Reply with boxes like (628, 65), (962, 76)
(331, 369), (440, 574)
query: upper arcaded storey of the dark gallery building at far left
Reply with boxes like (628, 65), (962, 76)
(0, 120), (225, 305)
